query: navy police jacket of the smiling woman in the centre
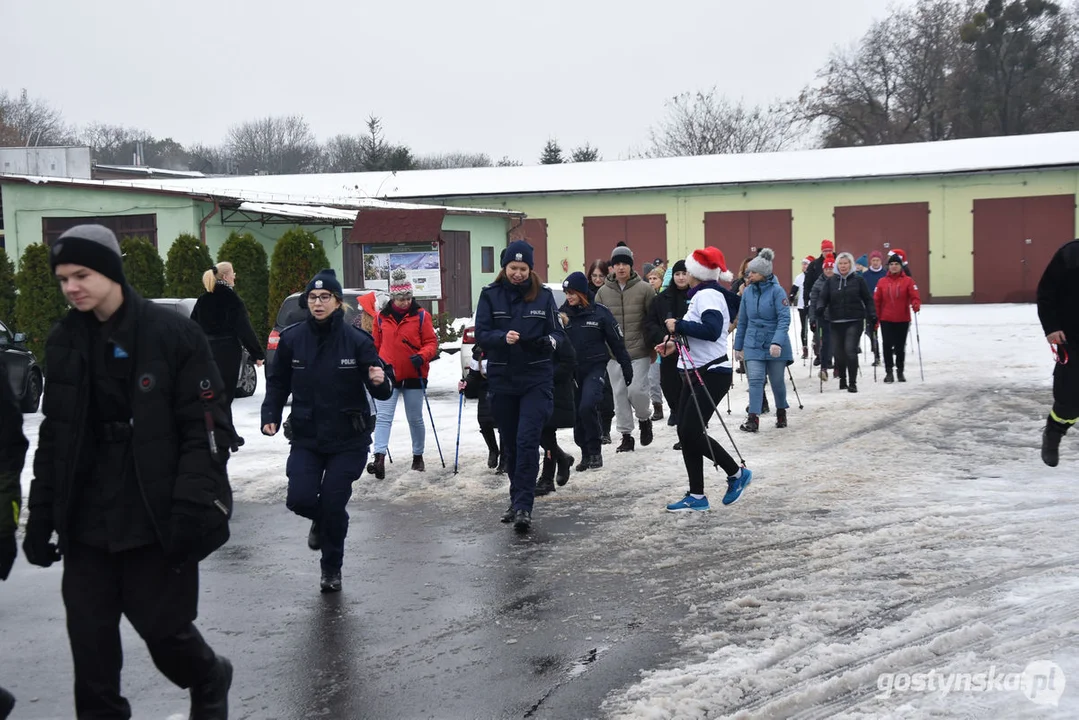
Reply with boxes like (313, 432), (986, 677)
(476, 280), (565, 395)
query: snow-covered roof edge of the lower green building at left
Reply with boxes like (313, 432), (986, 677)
(0, 173), (524, 220)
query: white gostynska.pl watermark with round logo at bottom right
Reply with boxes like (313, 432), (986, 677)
(875, 660), (1065, 706)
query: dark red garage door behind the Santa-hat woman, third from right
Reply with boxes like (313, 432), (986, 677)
(705, 210), (794, 288)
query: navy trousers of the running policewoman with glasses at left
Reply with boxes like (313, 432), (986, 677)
(285, 445), (367, 572)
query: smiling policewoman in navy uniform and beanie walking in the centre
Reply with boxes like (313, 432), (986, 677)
(476, 241), (564, 532)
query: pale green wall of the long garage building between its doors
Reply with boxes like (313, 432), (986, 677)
(427, 169), (1079, 297)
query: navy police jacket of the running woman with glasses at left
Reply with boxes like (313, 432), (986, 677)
(262, 310), (393, 453)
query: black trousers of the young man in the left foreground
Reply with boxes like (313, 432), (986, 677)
(62, 543), (216, 720)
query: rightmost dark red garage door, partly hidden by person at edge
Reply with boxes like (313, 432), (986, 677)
(974, 195), (1076, 302)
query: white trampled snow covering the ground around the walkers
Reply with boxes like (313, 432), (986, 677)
(16, 305), (1079, 719)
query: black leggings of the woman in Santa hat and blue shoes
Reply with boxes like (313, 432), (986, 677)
(678, 371), (738, 495)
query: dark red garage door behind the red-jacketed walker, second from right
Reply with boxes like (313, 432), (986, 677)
(833, 203), (930, 300)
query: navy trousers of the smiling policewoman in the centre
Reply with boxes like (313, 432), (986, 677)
(491, 385), (555, 513)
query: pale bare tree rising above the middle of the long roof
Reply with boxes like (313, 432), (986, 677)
(644, 87), (798, 158)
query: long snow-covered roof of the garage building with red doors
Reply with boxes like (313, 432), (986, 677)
(101, 132), (1079, 205)
